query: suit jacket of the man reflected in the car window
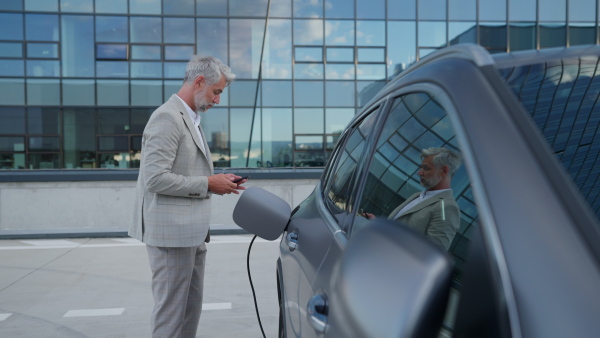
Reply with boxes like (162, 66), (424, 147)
(388, 190), (460, 250)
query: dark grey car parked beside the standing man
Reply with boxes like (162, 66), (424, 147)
(234, 45), (600, 338)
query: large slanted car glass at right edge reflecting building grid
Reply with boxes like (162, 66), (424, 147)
(500, 56), (600, 223)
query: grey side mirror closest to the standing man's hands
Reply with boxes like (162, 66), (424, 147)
(233, 187), (292, 241)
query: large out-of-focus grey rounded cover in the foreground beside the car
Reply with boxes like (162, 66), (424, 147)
(329, 219), (452, 338)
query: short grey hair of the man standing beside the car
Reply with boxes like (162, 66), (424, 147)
(183, 55), (235, 86)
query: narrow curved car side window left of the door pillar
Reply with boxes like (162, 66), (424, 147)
(323, 108), (377, 224)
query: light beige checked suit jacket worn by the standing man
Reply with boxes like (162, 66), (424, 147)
(129, 95), (213, 247)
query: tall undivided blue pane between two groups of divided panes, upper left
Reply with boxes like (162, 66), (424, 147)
(61, 15), (94, 77)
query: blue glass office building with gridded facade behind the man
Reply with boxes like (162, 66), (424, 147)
(0, 0), (600, 169)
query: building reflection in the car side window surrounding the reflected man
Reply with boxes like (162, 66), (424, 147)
(351, 92), (478, 278)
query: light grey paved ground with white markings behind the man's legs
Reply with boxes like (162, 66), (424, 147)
(0, 235), (279, 338)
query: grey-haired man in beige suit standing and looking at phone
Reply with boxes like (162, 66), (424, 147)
(129, 55), (246, 337)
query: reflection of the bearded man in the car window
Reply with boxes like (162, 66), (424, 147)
(389, 148), (461, 250)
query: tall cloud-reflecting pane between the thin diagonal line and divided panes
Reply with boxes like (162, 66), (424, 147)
(262, 19), (292, 79)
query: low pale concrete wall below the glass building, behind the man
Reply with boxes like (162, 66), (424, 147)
(0, 179), (318, 232)
